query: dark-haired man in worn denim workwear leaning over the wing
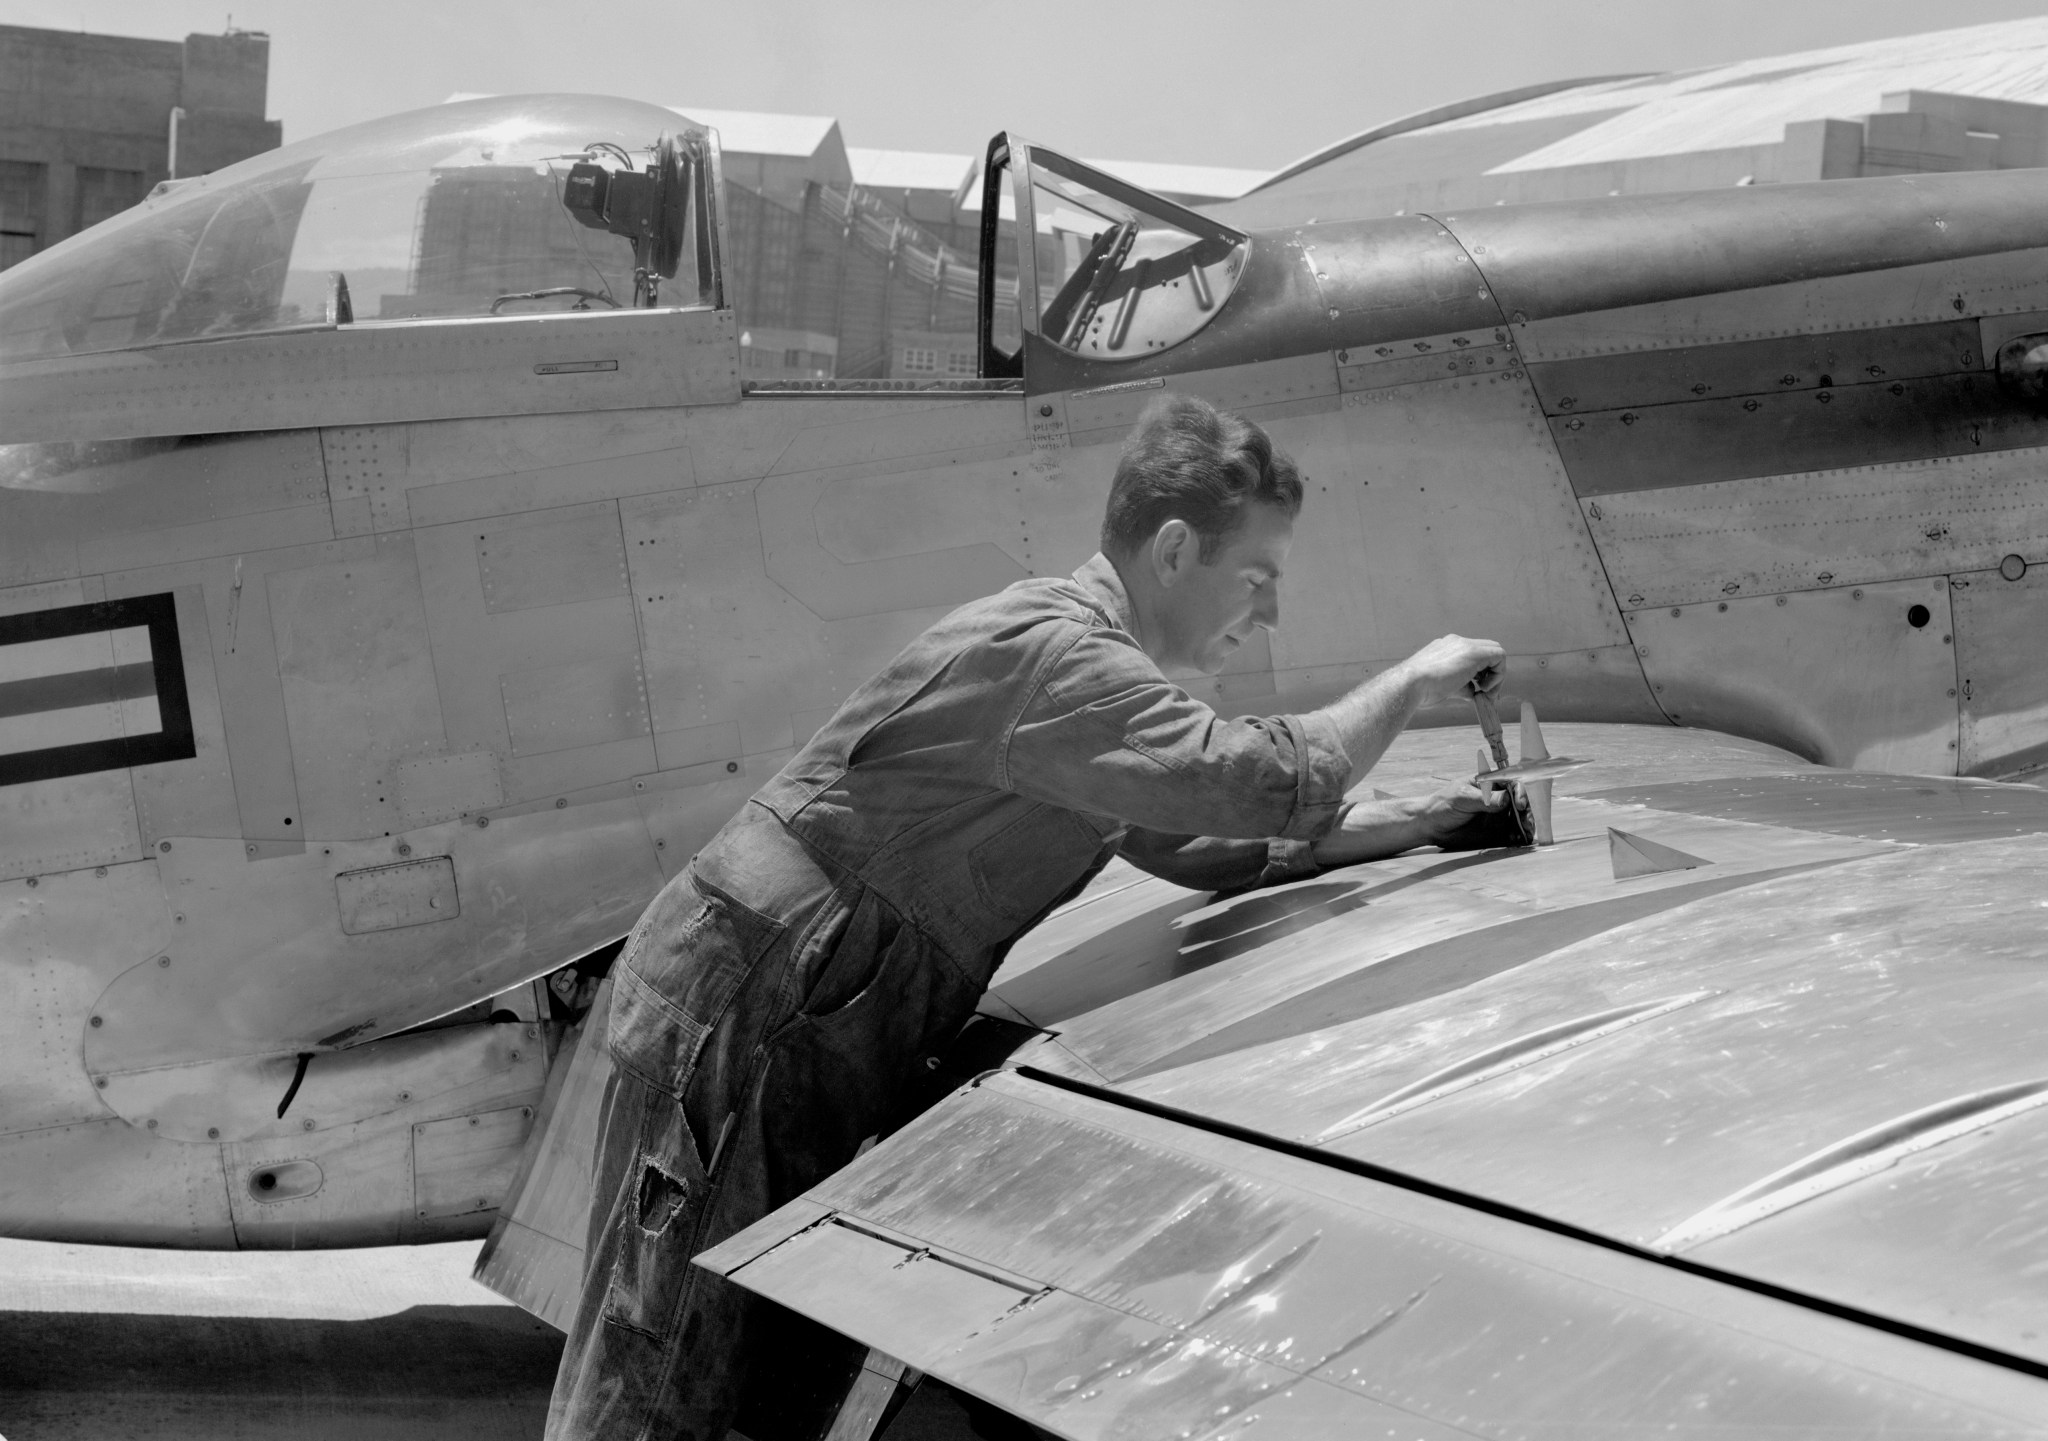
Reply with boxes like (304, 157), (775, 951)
(549, 395), (1513, 1441)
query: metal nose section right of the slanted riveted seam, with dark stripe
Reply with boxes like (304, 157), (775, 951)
(1444, 174), (2048, 776)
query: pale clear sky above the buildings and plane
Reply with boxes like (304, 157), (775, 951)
(12, 0), (2048, 170)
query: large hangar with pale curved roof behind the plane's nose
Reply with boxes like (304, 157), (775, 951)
(1219, 18), (2048, 225)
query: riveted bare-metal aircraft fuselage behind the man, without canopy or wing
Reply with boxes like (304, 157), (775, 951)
(0, 109), (2048, 1247)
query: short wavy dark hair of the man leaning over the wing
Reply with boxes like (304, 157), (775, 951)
(1102, 395), (1300, 563)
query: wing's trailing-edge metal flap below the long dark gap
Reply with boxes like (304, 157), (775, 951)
(700, 1071), (2044, 1441)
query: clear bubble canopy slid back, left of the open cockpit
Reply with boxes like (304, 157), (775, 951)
(0, 96), (702, 360)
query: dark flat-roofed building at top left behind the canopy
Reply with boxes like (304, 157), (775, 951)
(0, 25), (283, 268)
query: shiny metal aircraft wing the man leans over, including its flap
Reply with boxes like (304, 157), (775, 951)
(698, 727), (2048, 1437)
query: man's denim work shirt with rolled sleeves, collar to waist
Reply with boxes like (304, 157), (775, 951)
(754, 555), (1352, 976)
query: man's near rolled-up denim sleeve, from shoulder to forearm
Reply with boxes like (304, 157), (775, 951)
(999, 626), (1352, 843)
